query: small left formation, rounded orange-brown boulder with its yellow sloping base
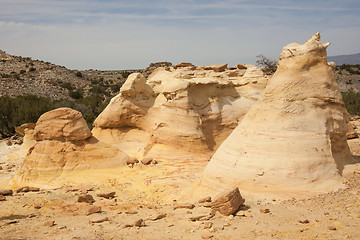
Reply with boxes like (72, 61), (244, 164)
(13, 108), (129, 185)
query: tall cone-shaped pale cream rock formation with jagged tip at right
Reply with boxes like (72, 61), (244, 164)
(199, 34), (352, 197)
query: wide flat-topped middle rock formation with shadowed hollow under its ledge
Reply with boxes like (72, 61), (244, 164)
(92, 64), (267, 160)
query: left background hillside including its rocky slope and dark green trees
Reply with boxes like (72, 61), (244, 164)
(0, 50), (136, 139)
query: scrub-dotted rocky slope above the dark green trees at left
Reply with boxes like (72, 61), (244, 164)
(0, 50), (134, 100)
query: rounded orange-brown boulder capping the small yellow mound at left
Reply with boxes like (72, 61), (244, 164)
(34, 108), (91, 141)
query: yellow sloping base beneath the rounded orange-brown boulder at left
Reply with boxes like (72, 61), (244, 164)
(13, 137), (129, 186)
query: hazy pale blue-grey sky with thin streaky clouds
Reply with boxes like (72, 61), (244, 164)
(0, 0), (360, 69)
